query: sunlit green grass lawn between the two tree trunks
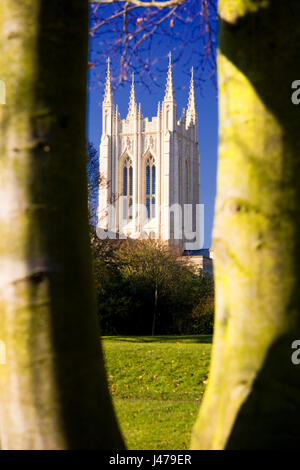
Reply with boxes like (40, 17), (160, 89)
(103, 335), (211, 450)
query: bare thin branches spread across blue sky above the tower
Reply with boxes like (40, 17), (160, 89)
(90, 0), (217, 90)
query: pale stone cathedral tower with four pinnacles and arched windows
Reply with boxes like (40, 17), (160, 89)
(98, 54), (200, 249)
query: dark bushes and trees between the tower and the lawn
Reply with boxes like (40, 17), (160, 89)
(91, 231), (214, 335)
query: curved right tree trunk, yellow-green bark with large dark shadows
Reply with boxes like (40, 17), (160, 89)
(192, 0), (300, 449)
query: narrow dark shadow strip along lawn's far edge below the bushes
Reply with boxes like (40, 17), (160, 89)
(102, 335), (212, 344)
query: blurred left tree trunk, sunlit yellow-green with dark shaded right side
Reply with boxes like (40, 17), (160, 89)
(0, 0), (123, 449)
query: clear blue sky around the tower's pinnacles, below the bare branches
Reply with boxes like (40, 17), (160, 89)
(87, 3), (218, 248)
